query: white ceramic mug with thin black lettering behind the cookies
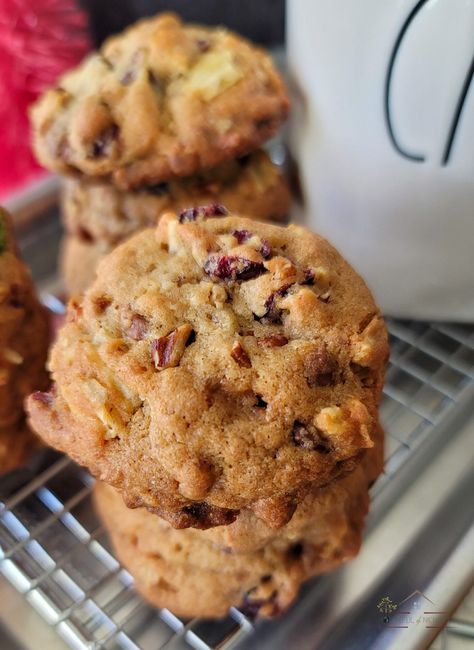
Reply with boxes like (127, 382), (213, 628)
(287, 0), (474, 321)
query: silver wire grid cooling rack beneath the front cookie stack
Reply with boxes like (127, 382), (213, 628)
(0, 320), (474, 650)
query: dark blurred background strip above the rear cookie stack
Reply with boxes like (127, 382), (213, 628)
(80, 0), (285, 46)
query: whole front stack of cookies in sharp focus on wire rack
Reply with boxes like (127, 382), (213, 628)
(28, 204), (388, 617)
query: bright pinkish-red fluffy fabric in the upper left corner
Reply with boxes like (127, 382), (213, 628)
(0, 0), (90, 198)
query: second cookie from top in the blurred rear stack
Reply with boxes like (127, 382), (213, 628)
(62, 150), (290, 245)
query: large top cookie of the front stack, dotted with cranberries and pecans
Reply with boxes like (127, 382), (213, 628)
(29, 210), (388, 528)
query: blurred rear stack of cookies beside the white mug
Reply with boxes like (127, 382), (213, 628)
(32, 14), (290, 293)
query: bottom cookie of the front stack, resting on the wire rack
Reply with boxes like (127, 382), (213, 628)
(94, 460), (368, 618)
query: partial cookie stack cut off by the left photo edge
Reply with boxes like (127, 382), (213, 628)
(0, 208), (49, 474)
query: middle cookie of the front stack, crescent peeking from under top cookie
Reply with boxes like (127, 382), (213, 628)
(201, 427), (384, 552)
